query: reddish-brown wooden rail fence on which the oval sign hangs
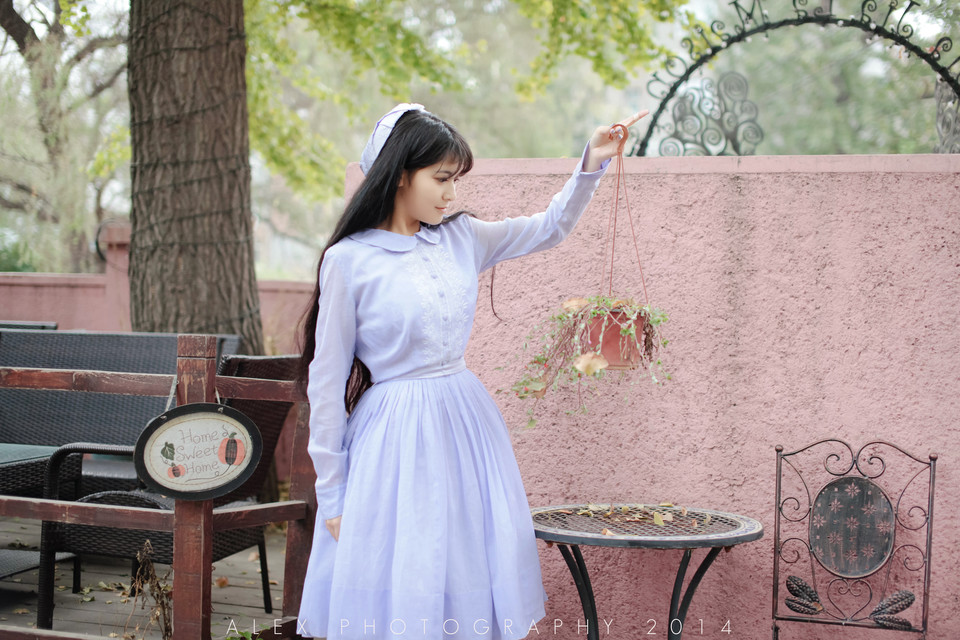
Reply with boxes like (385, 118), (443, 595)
(0, 336), (316, 640)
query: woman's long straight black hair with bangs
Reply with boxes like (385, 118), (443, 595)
(297, 110), (473, 413)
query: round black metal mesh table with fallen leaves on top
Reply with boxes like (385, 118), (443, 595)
(531, 504), (763, 640)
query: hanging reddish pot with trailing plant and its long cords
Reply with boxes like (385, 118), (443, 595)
(513, 124), (670, 427)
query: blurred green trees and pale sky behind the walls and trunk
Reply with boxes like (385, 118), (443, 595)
(0, 0), (960, 280)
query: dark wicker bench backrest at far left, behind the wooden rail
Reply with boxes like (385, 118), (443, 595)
(0, 329), (240, 445)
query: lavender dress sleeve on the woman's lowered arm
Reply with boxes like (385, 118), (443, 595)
(307, 248), (357, 520)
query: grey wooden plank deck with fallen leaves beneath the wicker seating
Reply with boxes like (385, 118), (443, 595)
(0, 518), (286, 640)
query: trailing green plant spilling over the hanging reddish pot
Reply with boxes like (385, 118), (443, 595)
(511, 296), (671, 427)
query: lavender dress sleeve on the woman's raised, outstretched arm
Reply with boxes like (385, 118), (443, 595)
(466, 142), (609, 271)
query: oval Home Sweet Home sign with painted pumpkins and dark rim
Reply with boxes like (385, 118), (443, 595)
(134, 402), (263, 500)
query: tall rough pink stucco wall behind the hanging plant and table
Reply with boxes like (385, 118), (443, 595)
(347, 155), (960, 640)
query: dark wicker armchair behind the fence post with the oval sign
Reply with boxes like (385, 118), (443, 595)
(37, 355), (297, 629)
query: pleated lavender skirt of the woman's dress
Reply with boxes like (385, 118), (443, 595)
(298, 370), (546, 640)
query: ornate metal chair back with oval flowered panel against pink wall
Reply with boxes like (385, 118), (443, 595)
(774, 439), (937, 631)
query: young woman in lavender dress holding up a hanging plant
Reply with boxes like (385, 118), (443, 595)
(299, 104), (646, 640)
